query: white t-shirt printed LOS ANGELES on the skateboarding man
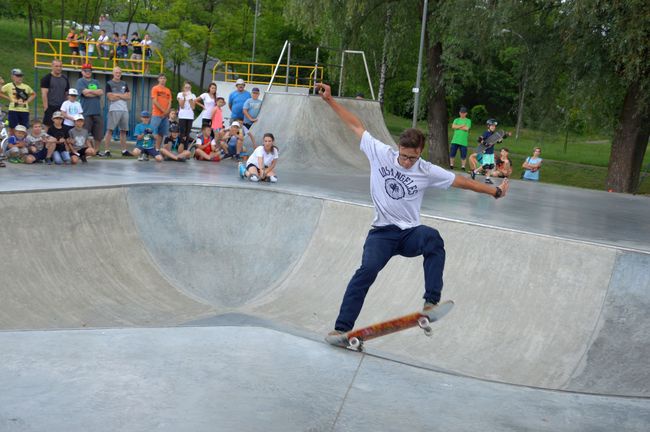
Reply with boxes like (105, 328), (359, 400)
(360, 131), (456, 229)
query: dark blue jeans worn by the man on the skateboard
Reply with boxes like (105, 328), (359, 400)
(334, 225), (445, 331)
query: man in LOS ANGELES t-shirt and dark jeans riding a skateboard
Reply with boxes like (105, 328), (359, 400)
(317, 84), (508, 335)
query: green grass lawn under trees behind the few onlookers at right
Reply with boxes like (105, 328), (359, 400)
(384, 114), (650, 195)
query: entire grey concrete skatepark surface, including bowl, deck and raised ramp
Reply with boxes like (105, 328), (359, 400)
(0, 94), (650, 431)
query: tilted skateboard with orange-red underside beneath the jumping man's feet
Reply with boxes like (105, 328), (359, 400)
(325, 300), (454, 351)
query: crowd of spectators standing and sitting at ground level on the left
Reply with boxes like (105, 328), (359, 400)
(0, 60), (278, 182)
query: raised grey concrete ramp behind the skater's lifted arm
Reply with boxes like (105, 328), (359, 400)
(251, 93), (394, 173)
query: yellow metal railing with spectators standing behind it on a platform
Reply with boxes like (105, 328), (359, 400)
(34, 39), (165, 75)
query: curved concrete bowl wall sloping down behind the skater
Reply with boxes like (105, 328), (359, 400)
(0, 184), (650, 398)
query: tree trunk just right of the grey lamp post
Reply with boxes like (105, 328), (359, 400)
(425, 35), (449, 166)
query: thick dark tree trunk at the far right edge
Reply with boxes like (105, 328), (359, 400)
(607, 81), (650, 193)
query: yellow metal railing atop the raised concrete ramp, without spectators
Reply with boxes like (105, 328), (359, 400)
(212, 61), (323, 88)
